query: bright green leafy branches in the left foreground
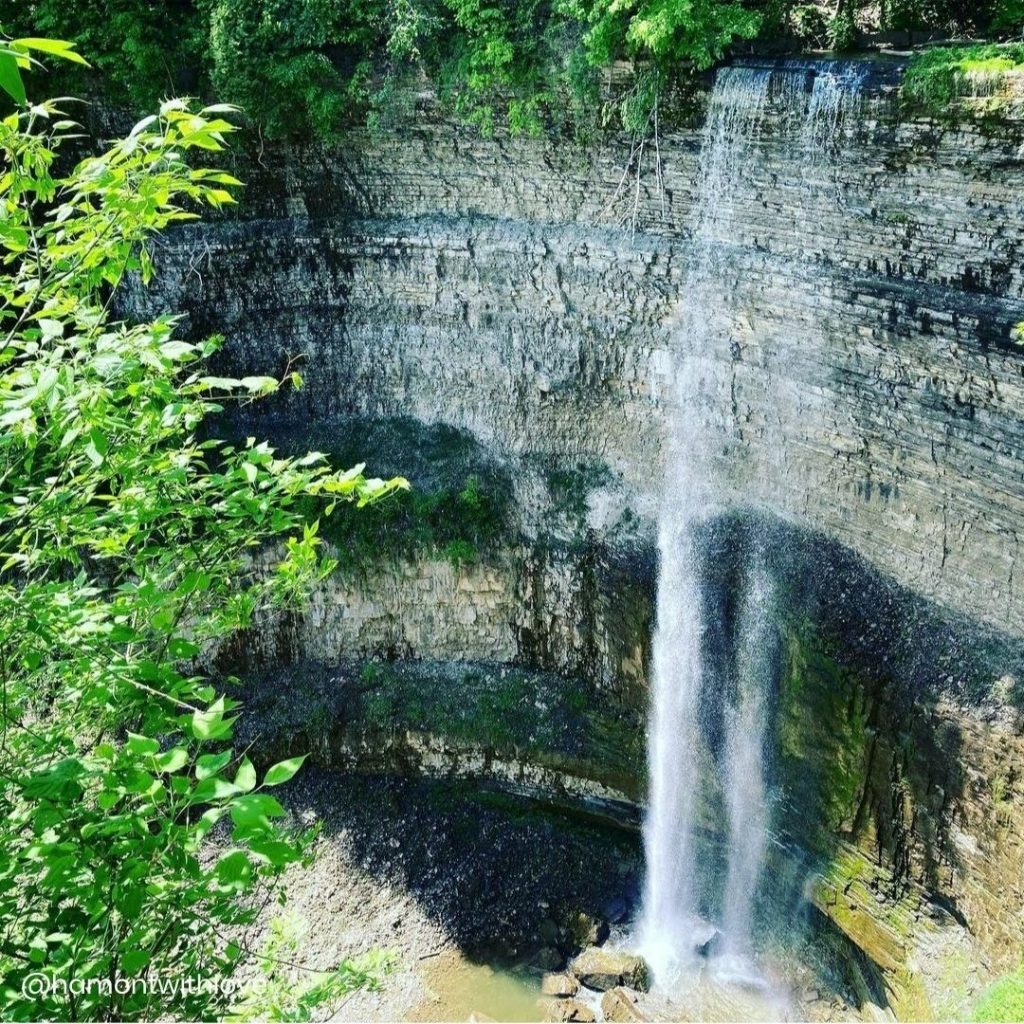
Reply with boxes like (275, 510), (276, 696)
(0, 40), (403, 1020)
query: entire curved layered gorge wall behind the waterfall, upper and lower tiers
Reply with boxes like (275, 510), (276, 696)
(128, 61), (1024, 1016)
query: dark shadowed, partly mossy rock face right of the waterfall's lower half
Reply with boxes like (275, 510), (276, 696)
(705, 512), (1024, 1005)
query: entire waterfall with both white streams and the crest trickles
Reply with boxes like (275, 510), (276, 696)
(639, 62), (860, 985)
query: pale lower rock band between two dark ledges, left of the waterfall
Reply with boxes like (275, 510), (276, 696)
(228, 546), (653, 711)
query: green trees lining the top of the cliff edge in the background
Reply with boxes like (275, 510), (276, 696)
(0, 0), (1024, 138)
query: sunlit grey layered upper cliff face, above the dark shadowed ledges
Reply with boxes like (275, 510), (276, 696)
(134, 59), (1024, 637)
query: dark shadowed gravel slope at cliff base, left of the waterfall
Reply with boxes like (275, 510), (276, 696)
(272, 769), (642, 969)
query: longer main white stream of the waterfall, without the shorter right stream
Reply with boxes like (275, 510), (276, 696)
(641, 68), (771, 978)
